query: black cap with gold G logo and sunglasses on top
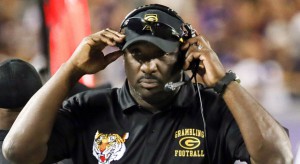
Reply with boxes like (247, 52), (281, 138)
(121, 4), (184, 52)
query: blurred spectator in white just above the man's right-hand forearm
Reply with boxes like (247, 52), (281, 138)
(230, 35), (291, 117)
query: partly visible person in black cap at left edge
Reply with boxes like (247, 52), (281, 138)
(0, 59), (42, 164)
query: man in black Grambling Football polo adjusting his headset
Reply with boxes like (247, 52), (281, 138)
(3, 5), (293, 164)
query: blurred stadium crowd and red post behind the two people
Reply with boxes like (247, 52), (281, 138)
(0, 0), (300, 161)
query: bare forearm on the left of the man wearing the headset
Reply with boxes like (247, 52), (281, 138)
(3, 64), (81, 163)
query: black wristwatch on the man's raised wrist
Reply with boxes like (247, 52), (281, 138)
(213, 70), (240, 94)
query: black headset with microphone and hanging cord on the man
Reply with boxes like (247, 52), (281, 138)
(118, 4), (211, 163)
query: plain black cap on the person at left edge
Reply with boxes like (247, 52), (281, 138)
(0, 59), (42, 108)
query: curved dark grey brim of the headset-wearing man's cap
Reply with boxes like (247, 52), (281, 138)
(122, 29), (179, 52)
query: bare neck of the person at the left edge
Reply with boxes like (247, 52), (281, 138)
(0, 108), (20, 130)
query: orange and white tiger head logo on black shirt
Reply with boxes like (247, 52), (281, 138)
(93, 131), (129, 164)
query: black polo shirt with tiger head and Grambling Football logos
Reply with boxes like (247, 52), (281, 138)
(45, 80), (250, 164)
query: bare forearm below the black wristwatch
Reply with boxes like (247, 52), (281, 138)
(223, 82), (293, 164)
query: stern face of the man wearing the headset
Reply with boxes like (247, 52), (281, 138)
(124, 42), (182, 103)
